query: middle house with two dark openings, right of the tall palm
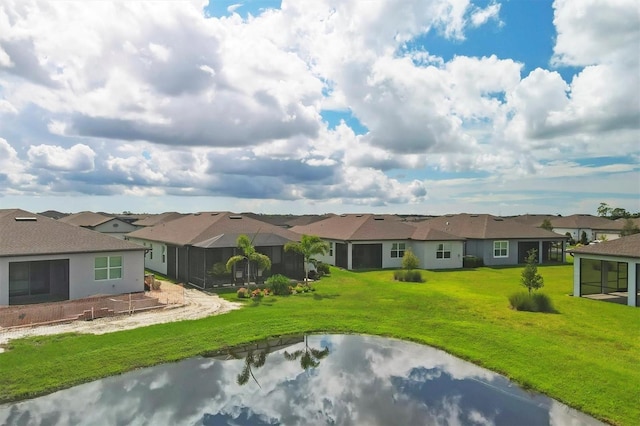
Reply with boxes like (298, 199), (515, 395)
(291, 214), (464, 269)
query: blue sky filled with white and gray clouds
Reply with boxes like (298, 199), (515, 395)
(0, 0), (640, 215)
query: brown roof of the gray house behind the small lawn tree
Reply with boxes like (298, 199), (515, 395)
(425, 213), (567, 240)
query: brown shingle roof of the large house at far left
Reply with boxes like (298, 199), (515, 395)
(0, 209), (145, 257)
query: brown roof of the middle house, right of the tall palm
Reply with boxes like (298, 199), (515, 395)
(291, 214), (463, 241)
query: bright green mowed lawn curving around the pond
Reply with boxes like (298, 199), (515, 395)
(0, 265), (640, 425)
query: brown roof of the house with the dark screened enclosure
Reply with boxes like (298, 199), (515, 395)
(128, 212), (300, 248)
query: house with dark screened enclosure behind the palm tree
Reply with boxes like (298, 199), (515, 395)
(127, 212), (304, 288)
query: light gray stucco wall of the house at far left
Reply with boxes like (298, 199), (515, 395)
(0, 251), (144, 305)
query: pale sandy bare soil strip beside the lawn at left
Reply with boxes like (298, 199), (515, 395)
(0, 282), (242, 352)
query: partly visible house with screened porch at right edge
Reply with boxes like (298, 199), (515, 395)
(571, 234), (640, 306)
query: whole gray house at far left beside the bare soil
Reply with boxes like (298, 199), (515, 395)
(0, 209), (145, 305)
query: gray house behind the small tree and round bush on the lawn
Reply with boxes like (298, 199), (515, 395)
(425, 213), (567, 266)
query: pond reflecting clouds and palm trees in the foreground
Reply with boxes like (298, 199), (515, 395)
(0, 335), (602, 426)
